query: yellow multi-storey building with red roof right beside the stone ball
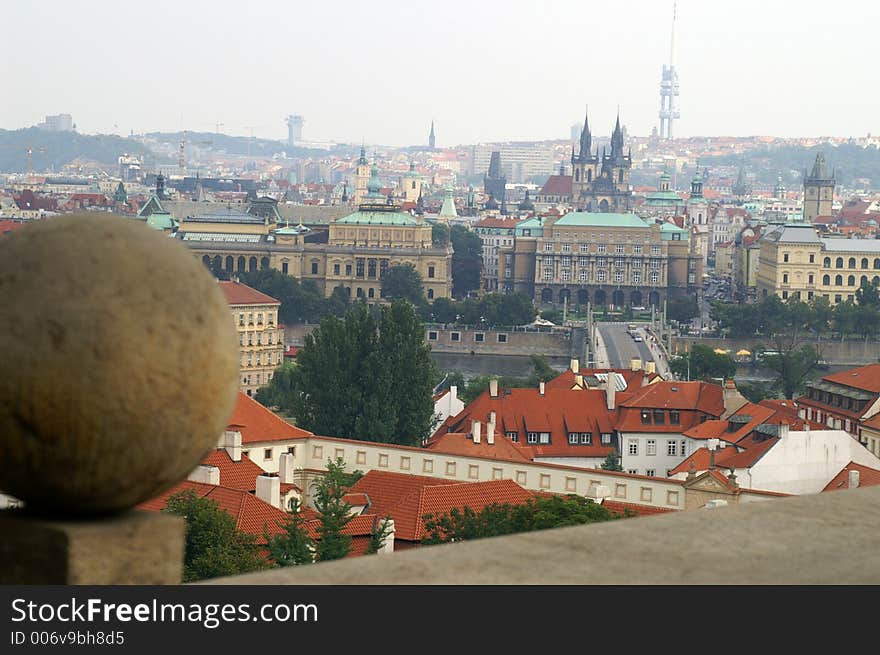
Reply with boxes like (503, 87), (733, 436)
(219, 281), (284, 396)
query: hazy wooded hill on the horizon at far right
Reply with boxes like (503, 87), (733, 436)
(700, 143), (880, 189)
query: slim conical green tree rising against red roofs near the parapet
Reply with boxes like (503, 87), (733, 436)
(313, 458), (354, 562)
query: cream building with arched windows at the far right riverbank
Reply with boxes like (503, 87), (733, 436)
(757, 223), (880, 305)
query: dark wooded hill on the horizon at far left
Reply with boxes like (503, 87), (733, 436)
(0, 127), (148, 173)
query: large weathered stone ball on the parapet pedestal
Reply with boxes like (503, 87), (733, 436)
(0, 214), (239, 516)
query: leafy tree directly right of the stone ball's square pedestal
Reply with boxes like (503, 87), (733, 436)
(163, 489), (268, 582)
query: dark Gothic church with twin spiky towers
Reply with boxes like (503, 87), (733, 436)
(571, 116), (632, 213)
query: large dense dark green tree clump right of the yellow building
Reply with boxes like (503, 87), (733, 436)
(289, 301), (435, 445)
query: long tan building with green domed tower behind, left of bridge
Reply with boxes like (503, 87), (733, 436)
(175, 164), (452, 301)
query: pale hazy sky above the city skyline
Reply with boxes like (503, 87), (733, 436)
(6, 0), (880, 146)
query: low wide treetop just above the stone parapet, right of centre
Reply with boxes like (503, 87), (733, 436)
(422, 494), (619, 544)
